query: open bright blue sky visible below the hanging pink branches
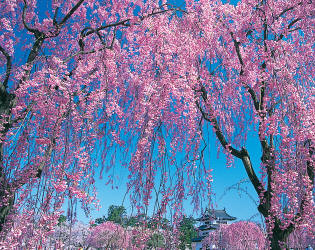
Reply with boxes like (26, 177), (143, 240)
(78, 127), (261, 225)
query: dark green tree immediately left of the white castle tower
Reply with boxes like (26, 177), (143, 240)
(178, 216), (197, 249)
